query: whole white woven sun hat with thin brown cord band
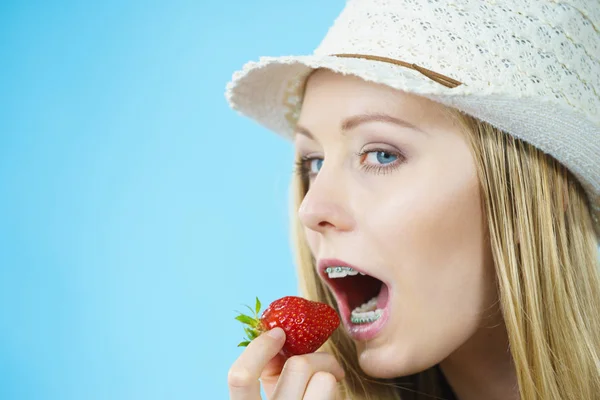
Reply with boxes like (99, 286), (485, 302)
(226, 0), (600, 238)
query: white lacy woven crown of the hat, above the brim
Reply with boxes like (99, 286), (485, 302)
(314, 0), (600, 125)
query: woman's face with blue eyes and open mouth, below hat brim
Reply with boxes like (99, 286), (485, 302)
(295, 70), (497, 378)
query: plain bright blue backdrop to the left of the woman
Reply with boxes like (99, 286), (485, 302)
(0, 0), (344, 400)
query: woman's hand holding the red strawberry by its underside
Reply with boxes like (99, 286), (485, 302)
(227, 328), (344, 400)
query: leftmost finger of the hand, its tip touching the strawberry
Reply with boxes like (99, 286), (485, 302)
(227, 328), (285, 400)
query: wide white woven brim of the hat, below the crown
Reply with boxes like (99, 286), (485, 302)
(226, 55), (600, 238)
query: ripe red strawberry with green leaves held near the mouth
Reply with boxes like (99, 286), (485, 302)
(236, 296), (340, 357)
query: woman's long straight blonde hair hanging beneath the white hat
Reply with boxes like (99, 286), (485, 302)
(291, 109), (600, 400)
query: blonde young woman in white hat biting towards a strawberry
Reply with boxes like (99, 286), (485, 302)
(227, 0), (600, 400)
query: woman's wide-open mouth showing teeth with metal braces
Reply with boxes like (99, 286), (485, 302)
(324, 266), (388, 324)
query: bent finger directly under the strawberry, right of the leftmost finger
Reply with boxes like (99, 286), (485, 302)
(273, 352), (345, 400)
